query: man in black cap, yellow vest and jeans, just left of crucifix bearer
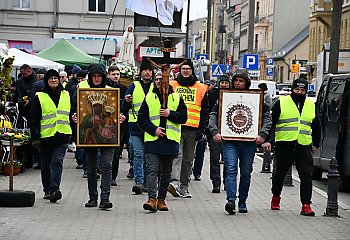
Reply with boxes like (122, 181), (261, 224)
(122, 60), (153, 194)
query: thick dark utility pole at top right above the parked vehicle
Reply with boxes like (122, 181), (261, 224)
(328, 0), (343, 74)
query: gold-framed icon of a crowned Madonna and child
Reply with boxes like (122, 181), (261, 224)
(77, 88), (120, 147)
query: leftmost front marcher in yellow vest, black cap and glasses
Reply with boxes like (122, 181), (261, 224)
(30, 69), (72, 202)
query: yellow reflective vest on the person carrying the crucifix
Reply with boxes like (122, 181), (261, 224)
(145, 92), (181, 143)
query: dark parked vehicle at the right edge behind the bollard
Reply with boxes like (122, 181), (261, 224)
(313, 74), (350, 192)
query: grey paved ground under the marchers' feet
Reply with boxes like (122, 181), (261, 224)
(0, 150), (350, 240)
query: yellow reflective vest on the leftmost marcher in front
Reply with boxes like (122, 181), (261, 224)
(36, 90), (72, 138)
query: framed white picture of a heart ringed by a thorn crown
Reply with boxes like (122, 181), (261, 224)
(218, 89), (264, 141)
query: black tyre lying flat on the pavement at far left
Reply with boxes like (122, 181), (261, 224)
(0, 191), (35, 207)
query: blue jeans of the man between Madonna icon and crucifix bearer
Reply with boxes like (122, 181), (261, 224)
(130, 135), (146, 185)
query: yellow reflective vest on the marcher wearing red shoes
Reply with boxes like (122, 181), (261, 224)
(276, 96), (315, 145)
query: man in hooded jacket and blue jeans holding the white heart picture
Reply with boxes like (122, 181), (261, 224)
(209, 69), (271, 215)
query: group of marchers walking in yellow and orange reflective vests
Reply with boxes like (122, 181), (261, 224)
(20, 57), (320, 216)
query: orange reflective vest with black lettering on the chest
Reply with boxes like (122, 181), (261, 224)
(170, 81), (207, 128)
